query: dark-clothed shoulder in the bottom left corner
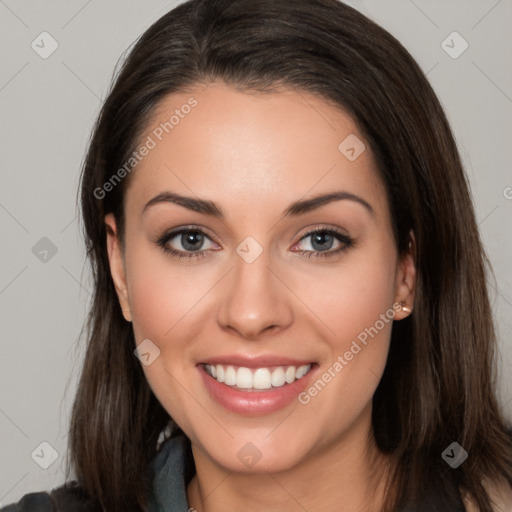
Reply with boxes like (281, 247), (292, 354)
(0, 482), (99, 512)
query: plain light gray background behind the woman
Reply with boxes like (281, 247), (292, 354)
(0, 0), (512, 505)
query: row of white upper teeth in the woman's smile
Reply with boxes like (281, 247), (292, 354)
(205, 364), (311, 390)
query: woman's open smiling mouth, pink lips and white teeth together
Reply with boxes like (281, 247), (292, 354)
(197, 361), (318, 416)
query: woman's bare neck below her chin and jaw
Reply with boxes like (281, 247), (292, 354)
(187, 405), (389, 512)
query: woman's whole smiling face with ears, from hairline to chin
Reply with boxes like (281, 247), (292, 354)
(106, 83), (414, 472)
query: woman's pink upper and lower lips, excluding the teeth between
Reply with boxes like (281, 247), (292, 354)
(196, 357), (318, 416)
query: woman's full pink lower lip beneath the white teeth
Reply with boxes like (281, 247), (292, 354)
(197, 364), (316, 416)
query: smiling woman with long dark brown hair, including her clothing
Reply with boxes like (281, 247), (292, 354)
(2, 0), (512, 512)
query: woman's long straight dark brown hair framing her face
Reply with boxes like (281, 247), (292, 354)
(70, 0), (512, 512)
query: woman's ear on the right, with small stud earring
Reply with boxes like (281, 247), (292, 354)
(394, 231), (416, 320)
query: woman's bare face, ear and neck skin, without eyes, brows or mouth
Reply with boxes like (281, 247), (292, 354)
(105, 82), (415, 512)
